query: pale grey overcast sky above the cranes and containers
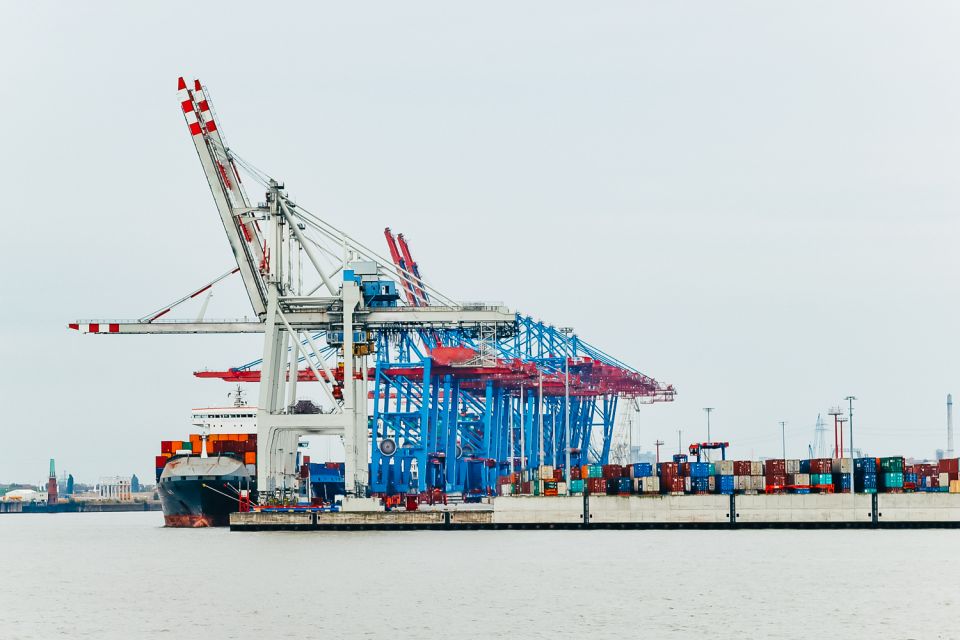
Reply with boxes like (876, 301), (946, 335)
(0, 0), (960, 482)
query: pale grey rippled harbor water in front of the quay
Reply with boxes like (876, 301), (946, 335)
(0, 512), (960, 640)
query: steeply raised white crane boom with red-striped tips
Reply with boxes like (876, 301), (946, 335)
(177, 78), (267, 318)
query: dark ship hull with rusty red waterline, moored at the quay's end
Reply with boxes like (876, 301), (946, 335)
(157, 456), (256, 527)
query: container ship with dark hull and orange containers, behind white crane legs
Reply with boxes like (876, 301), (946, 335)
(156, 388), (344, 527)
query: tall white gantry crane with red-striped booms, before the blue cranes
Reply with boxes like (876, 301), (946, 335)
(70, 78), (515, 510)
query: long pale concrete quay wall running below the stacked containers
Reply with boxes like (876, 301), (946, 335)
(230, 493), (960, 531)
